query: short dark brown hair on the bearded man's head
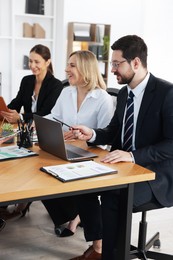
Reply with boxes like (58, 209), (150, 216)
(111, 35), (148, 68)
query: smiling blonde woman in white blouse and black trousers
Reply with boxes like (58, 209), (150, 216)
(43, 51), (114, 237)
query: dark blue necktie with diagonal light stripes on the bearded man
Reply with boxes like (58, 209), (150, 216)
(123, 91), (134, 151)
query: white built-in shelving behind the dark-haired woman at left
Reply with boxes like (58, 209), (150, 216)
(0, 0), (56, 102)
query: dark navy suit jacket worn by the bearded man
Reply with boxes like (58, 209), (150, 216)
(95, 75), (173, 206)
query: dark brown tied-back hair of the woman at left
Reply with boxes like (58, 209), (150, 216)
(30, 44), (53, 74)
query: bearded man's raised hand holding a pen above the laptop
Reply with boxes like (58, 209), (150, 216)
(71, 125), (93, 141)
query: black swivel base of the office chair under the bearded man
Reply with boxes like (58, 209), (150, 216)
(129, 211), (173, 260)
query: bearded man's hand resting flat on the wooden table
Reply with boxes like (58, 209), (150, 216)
(101, 150), (132, 163)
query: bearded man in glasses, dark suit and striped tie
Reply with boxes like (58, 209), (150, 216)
(69, 35), (173, 260)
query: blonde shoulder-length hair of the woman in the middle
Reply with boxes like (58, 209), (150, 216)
(69, 51), (106, 91)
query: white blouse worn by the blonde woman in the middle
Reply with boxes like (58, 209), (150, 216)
(46, 86), (114, 131)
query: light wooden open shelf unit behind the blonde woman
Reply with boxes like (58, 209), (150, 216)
(67, 22), (111, 83)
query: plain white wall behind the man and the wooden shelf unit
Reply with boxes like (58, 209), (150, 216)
(56, 0), (173, 87)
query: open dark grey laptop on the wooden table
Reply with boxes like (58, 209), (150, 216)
(34, 115), (98, 161)
